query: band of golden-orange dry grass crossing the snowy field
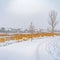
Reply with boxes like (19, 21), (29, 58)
(0, 33), (60, 42)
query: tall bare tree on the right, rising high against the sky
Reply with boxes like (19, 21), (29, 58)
(49, 10), (57, 34)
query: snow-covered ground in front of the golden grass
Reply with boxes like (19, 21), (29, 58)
(0, 36), (60, 60)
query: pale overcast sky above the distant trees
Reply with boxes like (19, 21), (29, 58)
(0, 0), (60, 29)
